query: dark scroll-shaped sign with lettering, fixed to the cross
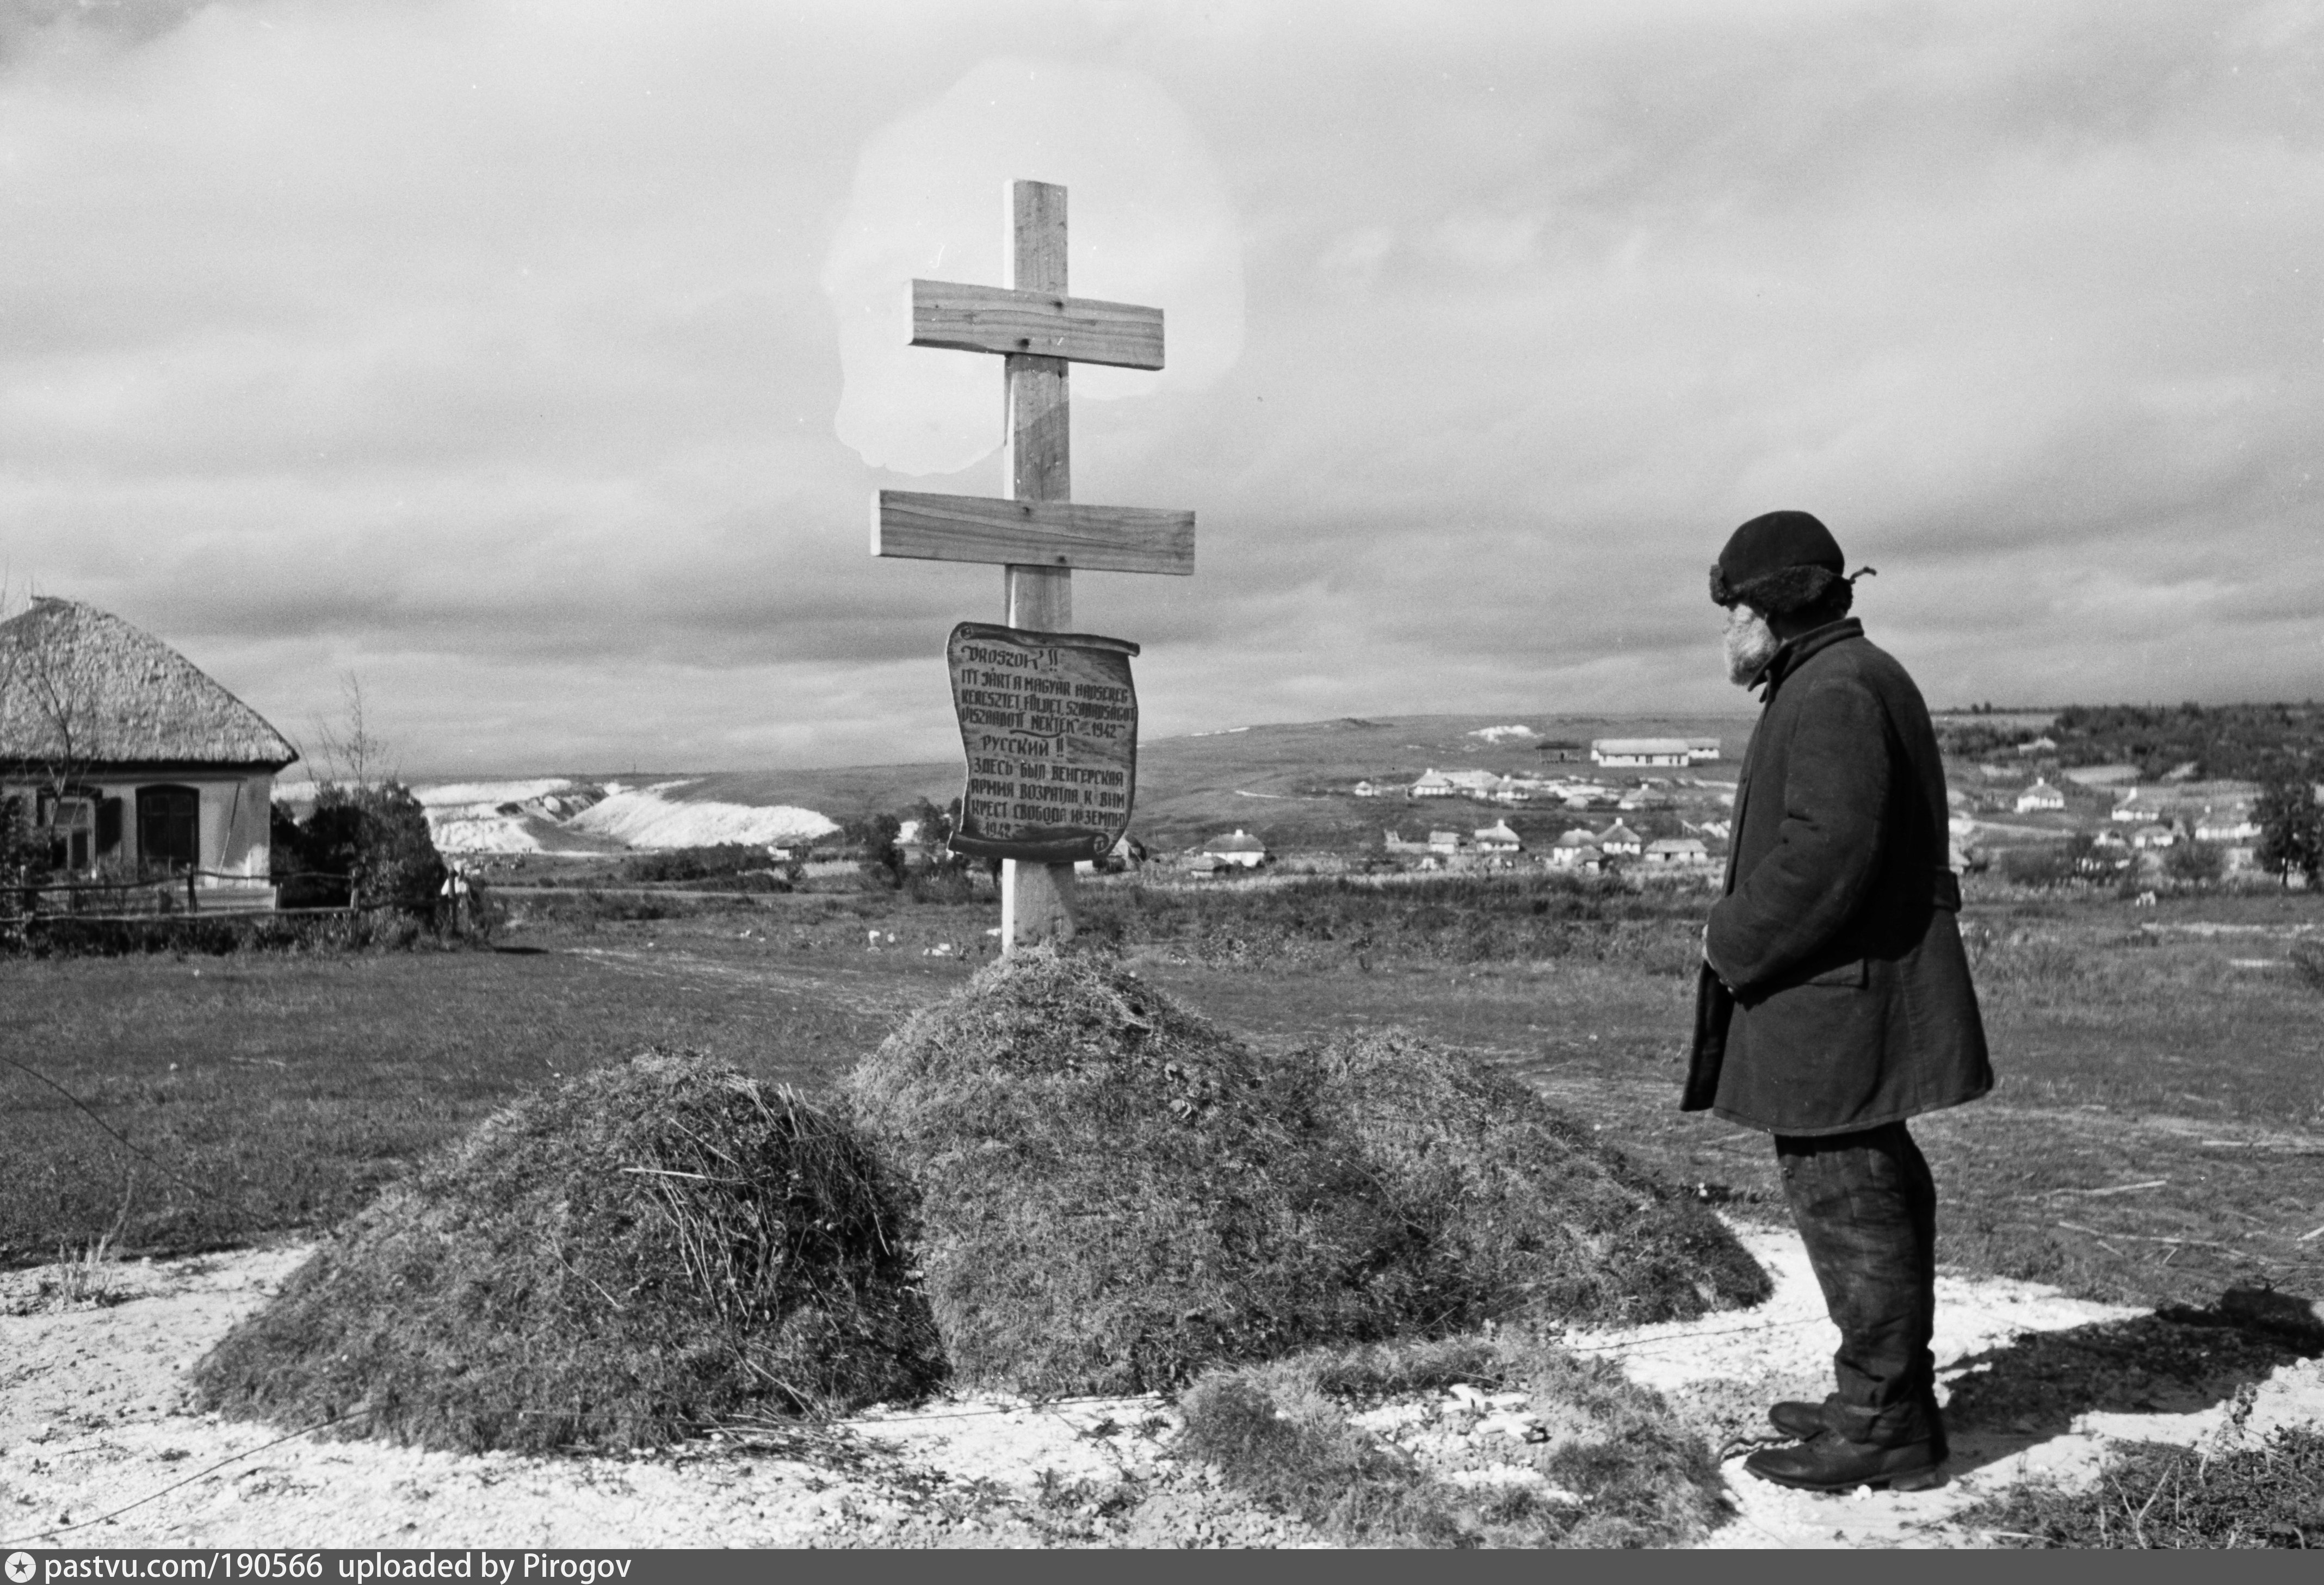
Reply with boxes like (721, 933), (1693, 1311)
(943, 623), (1139, 864)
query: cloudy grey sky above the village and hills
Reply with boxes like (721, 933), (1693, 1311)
(0, 0), (2324, 774)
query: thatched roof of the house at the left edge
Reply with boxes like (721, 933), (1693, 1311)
(0, 597), (298, 769)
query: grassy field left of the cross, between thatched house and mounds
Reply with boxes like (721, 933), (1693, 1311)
(0, 911), (990, 1264)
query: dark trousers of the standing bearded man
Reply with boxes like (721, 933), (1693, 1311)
(1776, 1123), (1945, 1448)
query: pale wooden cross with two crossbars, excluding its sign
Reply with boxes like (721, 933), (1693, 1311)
(872, 181), (1195, 953)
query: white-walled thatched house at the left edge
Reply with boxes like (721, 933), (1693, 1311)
(0, 597), (298, 909)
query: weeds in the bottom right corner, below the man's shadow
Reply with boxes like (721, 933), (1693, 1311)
(1959, 1425), (2324, 1548)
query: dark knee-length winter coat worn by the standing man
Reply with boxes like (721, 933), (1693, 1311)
(1680, 621), (1994, 1134)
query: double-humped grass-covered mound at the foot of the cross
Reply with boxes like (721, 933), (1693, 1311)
(848, 953), (1766, 1395)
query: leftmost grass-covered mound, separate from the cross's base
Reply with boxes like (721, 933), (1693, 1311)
(195, 1050), (943, 1450)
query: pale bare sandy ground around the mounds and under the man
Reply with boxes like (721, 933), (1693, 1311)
(0, 1227), (2324, 1548)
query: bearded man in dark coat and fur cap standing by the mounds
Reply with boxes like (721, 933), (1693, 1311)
(1680, 511), (1994, 1492)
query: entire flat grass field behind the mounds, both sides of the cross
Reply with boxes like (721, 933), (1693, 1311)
(0, 888), (2324, 1304)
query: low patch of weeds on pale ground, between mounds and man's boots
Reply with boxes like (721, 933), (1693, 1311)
(1178, 1336), (1725, 1548)
